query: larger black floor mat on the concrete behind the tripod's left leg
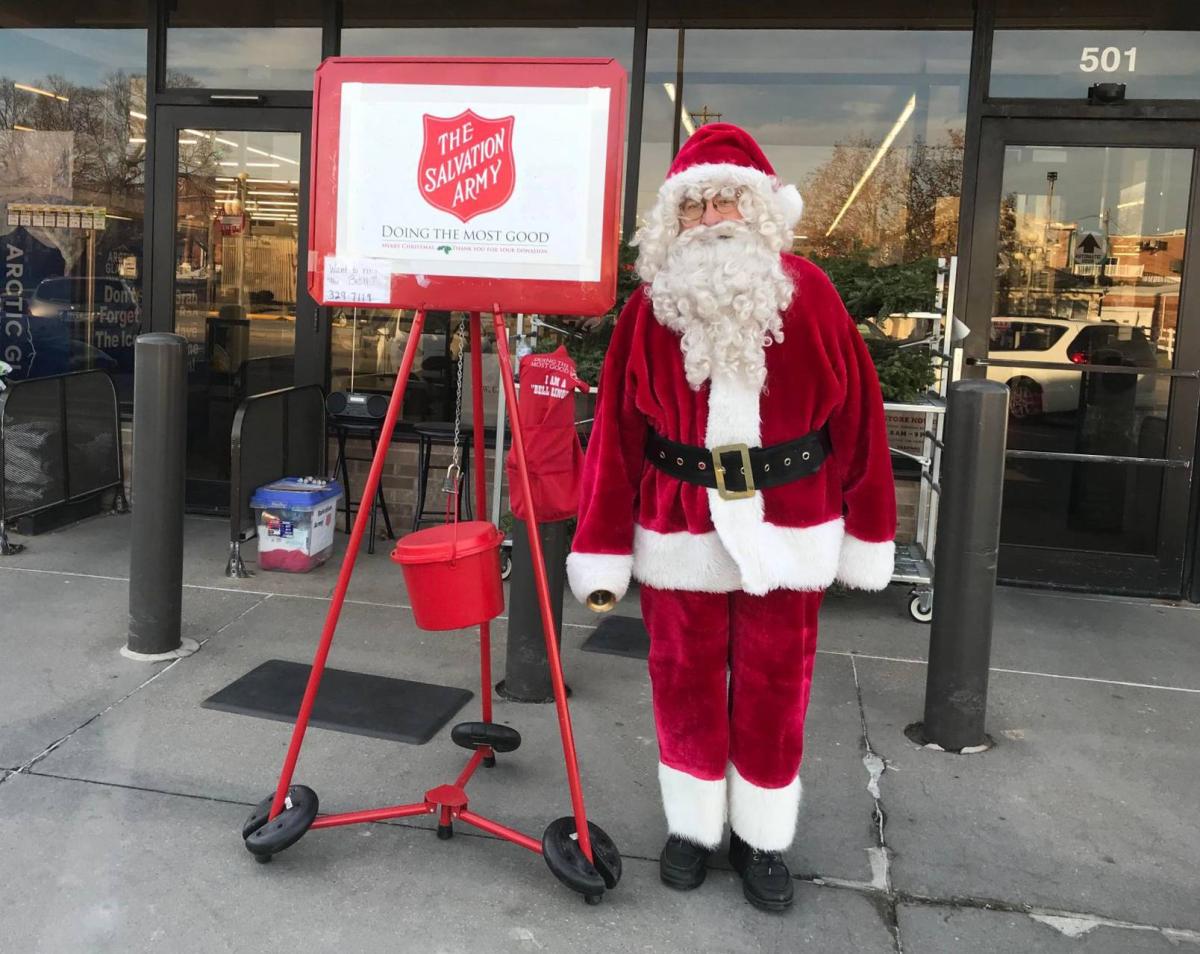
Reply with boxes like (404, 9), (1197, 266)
(200, 659), (474, 745)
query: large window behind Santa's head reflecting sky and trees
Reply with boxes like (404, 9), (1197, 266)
(638, 29), (971, 324)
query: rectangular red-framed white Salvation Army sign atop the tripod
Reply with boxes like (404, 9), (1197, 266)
(308, 58), (625, 314)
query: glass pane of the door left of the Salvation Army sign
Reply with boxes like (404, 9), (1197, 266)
(174, 128), (300, 492)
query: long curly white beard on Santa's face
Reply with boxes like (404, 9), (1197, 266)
(650, 221), (794, 391)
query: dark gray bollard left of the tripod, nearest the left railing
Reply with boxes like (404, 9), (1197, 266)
(121, 334), (196, 659)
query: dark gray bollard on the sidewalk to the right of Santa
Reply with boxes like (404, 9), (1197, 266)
(918, 380), (1008, 752)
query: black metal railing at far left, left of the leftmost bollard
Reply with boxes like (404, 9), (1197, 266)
(0, 371), (128, 556)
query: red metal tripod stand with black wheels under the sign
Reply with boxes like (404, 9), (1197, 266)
(242, 306), (620, 904)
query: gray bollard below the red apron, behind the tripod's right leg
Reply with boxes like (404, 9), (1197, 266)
(496, 520), (570, 702)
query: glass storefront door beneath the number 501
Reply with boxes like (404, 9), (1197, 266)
(968, 120), (1200, 596)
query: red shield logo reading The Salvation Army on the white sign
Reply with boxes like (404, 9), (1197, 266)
(416, 109), (516, 222)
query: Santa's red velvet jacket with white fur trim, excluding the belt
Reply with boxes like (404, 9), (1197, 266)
(568, 254), (896, 600)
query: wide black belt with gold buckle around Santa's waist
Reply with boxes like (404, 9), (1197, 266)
(646, 427), (829, 500)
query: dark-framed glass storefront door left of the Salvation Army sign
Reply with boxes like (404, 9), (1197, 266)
(154, 107), (320, 511)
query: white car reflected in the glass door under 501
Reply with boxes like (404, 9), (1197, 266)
(988, 318), (1158, 418)
